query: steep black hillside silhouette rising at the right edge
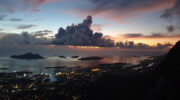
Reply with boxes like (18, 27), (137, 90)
(148, 41), (180, 100)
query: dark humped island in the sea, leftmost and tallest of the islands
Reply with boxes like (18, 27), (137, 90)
(10, 52), (44, 60)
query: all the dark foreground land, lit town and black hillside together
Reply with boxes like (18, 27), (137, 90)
(0, 42), (180, 100)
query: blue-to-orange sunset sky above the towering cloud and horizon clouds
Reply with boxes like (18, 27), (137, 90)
(0, 0), (180, 45)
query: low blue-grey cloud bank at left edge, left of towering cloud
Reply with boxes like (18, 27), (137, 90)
(0, 32), (50, 45)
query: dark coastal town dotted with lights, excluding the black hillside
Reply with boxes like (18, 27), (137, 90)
(0, 57), (165, 100)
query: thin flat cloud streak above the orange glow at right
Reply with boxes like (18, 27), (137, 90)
(120, 33), (180, 38)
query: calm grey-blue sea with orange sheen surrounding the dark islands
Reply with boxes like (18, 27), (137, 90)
(0, 46), (167, 74)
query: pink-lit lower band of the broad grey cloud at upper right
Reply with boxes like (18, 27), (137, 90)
(92, 0), (175, 23)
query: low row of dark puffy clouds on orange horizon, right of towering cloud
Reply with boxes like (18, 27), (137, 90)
(116, 41), (173, 49)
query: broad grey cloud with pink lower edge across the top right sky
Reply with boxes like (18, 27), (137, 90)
(63, 0), (176, 24)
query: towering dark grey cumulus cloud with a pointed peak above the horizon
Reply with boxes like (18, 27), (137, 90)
(53, 16), (114, 47)
